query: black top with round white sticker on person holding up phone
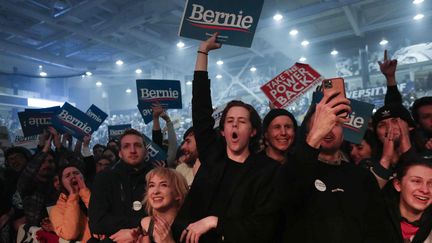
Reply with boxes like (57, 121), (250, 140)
(278, 143), (390, 243)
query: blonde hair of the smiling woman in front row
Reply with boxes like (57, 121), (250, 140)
(143, 167), (189, 216)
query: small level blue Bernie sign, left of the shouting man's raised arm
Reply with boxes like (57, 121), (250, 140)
(136, 79), (182, 109)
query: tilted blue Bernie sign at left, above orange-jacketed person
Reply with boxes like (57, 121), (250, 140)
(52, 102), (99, 141)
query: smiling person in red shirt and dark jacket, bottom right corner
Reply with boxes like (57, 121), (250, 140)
(383, 160), (432, 243)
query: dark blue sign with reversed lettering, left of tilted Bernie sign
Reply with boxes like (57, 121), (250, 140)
(18, 106), (60, 137)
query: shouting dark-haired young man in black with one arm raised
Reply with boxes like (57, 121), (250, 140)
(171, 34), (278, 242)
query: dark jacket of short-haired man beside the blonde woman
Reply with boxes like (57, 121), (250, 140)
(88, 161), (152, 236)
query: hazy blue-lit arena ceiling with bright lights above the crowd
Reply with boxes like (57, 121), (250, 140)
(0, 0), (432, 90)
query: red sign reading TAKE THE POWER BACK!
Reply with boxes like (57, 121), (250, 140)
(261, 63), (324, 108)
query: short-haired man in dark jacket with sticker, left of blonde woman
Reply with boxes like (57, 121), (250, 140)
(89, 129), (152, 242)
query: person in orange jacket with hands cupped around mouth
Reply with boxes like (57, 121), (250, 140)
(50, 164), (91, 242)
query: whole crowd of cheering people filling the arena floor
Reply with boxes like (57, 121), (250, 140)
(0, 34), (432, 243)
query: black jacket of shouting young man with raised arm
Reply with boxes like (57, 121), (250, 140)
(171, 72), (278, 242)
